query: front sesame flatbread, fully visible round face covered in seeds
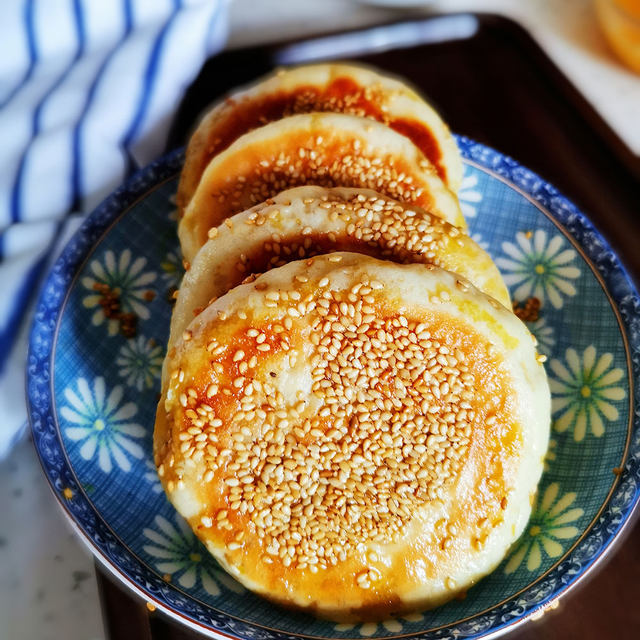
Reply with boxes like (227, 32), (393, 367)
(154, 253), (550, 621)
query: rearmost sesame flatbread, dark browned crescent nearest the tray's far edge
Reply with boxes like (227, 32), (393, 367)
(177, 64), (462, 209)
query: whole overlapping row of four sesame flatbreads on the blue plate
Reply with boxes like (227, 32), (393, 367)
(154, 64), (550, 621)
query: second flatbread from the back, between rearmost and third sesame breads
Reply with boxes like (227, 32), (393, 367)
(178, 113), (465, 262)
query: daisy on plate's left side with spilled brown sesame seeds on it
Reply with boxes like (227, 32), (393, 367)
(82, 249), (156, 336)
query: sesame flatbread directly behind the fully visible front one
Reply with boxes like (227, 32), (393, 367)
(169, 187), (511, 360)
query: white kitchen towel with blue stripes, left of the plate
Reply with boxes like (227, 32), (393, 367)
(0, 0), (227, 458)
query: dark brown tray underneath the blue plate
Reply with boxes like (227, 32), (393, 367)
(98, 14), (640, 640)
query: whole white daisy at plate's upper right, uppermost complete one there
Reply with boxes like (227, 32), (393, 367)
(496, 229), (580, 309)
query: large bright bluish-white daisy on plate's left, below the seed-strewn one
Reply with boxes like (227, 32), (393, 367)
(60, 377), (145, 473)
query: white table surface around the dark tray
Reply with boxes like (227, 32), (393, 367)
(0, 0), (640, 640)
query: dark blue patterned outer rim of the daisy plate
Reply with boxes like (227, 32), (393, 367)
(26, 136), (640, 640)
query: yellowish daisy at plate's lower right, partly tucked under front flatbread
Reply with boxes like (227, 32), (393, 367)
(504, 482), (584, 574)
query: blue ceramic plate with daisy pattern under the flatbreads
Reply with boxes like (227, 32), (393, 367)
(28, 138), (640, 640)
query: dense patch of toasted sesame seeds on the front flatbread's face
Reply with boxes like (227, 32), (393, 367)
(172, 272), (512, 576)
